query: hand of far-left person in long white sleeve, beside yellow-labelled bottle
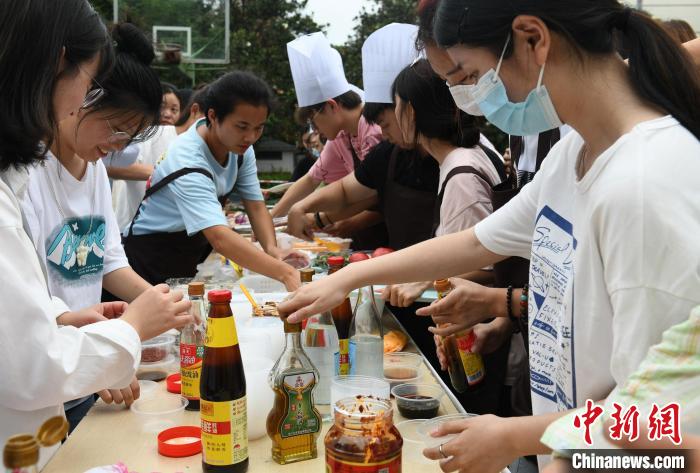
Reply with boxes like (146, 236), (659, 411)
(121, 284), (194, 340)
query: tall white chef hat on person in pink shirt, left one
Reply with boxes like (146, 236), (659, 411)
(287, 32), (363, 107)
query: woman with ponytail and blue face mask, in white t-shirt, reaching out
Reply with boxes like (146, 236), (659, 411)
(280, 0), (700, 472)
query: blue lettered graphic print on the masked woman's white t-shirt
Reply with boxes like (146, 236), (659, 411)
(528, 206), (577, 409)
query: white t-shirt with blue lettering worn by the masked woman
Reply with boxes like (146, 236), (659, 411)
(475, 117), (700, 467)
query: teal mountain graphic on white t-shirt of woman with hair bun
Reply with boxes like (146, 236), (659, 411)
(46, 215), (105, 285)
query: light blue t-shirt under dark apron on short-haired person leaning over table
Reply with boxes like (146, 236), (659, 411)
(130, 119), (263, 236)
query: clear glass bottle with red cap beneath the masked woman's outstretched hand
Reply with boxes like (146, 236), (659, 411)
(300, 269), (339, 405)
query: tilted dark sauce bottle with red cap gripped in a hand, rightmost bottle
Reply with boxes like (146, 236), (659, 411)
(434, 279), (486, 393)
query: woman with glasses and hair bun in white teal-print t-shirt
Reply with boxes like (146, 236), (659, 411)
(22, 23), (168, 429)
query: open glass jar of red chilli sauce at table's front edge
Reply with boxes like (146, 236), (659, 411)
(325, 396), (403, 473)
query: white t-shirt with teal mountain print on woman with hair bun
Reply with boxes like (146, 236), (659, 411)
(22, 153), (129, 315)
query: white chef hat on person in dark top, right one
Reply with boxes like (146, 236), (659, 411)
(362, 23), (419, 103)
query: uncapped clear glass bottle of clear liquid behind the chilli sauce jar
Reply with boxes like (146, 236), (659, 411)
(349, 286), (384, 378)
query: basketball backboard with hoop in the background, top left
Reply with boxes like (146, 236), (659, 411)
(113, 0), (231, 64)
